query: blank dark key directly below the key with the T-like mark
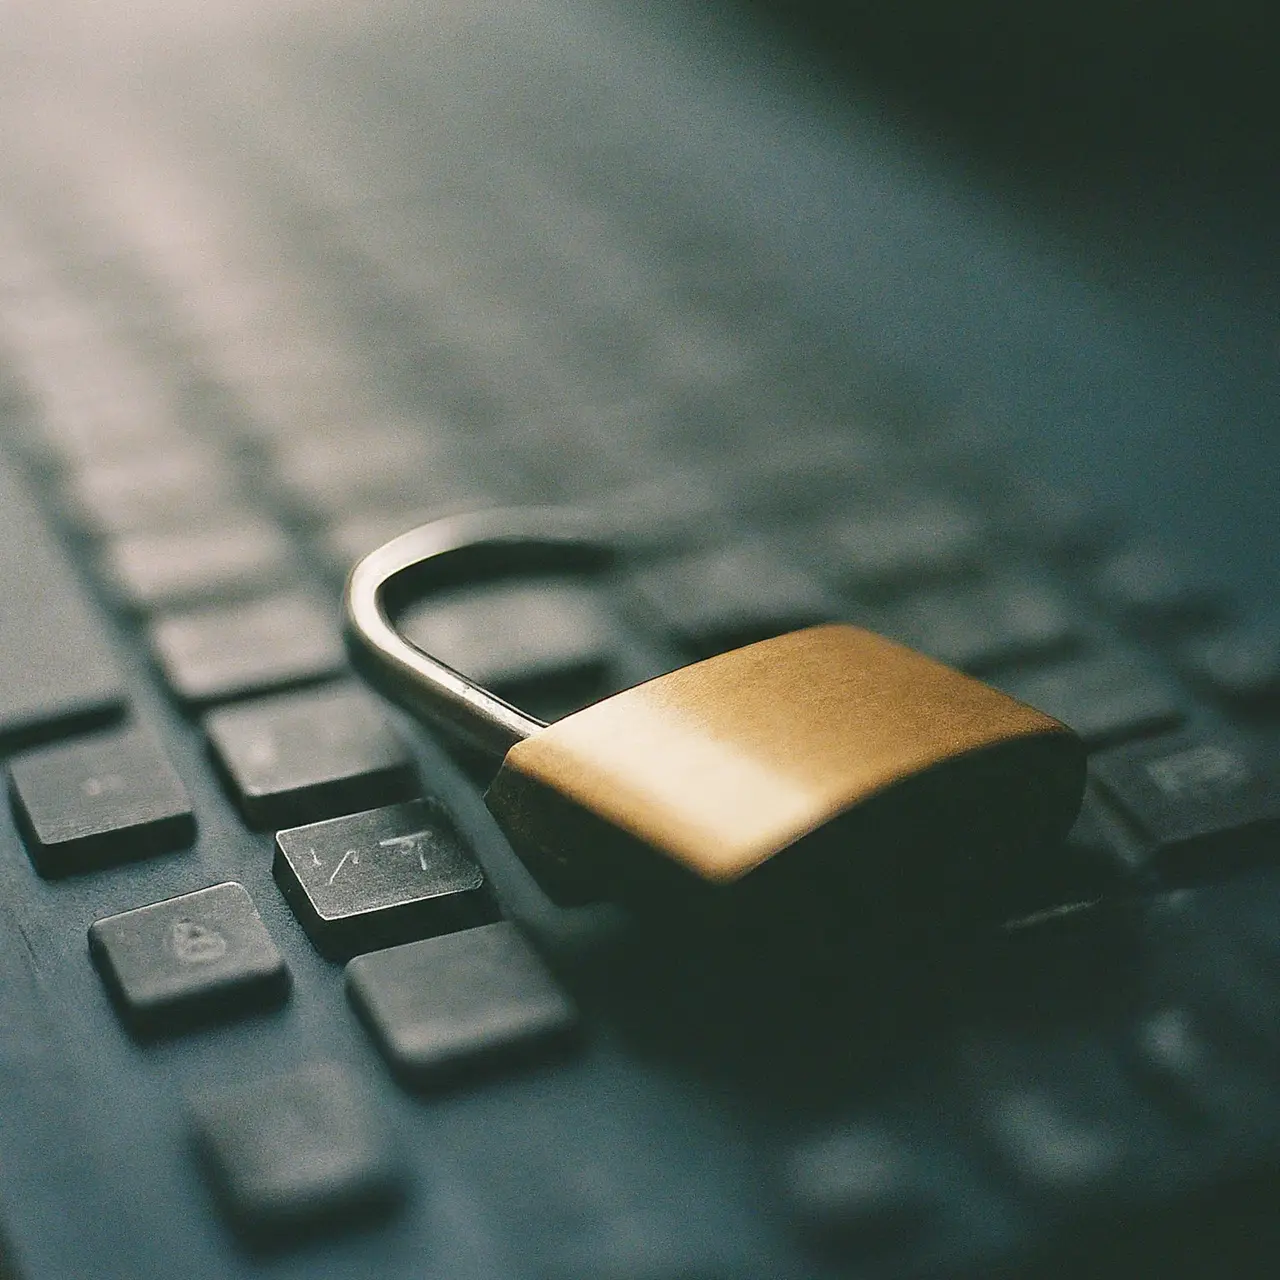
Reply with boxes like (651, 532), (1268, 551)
(347, 923), (577, 1084)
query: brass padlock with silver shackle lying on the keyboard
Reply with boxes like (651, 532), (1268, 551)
(346, 512), (1084, 909)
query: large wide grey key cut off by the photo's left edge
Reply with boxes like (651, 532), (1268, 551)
(0, 467), (125, 750)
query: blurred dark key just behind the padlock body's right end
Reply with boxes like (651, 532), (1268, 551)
(998, 655), (1183, 746)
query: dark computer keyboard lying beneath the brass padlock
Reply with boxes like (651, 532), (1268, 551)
(0, 0), (1280, 1280)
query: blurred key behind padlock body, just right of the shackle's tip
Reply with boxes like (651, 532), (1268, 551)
(630, 544), (833, 657)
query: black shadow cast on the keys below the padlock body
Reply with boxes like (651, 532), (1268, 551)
(537, 860), (1135, 1117)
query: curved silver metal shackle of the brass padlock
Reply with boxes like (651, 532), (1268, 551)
(343, 508), (613, 763)
